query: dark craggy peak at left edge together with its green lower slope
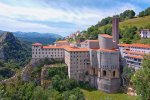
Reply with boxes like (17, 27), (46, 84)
(0, 32), (31, 80)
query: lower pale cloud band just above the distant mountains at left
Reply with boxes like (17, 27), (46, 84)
(0, 18), (75, 35)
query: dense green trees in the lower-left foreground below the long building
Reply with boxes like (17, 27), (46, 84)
(0, 59), (85, 100)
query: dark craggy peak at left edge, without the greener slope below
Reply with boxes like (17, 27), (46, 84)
(0, 32), (31, 66)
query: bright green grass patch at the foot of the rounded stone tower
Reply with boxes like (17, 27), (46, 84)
(81, 89), (137, 100)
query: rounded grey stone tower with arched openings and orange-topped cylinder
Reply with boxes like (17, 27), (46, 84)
(97, 34), (120, 93)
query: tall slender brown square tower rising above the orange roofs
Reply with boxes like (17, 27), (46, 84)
(112, 16), (119, 48)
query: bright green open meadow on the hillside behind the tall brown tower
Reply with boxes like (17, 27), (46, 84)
(99, 16), (150, 30)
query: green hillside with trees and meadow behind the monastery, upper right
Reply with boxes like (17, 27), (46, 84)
(76, 7), (150, 44)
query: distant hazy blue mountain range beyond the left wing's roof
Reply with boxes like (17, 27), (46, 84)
(13, 31), (63, 44)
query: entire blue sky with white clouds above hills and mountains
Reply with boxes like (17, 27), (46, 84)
(0, 0), (150, 36)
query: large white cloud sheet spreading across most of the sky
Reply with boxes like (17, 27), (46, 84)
(0, 0), (137, 32)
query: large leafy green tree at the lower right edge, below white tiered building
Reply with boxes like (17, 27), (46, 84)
(132, 55), (150, 100)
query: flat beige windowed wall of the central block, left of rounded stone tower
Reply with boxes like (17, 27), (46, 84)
(65, 51), (89, 81)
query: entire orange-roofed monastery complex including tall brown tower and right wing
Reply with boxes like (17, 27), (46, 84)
(32, 17), (150, 93)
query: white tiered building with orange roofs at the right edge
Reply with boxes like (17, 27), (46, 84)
(119, 44), (150, 70)
